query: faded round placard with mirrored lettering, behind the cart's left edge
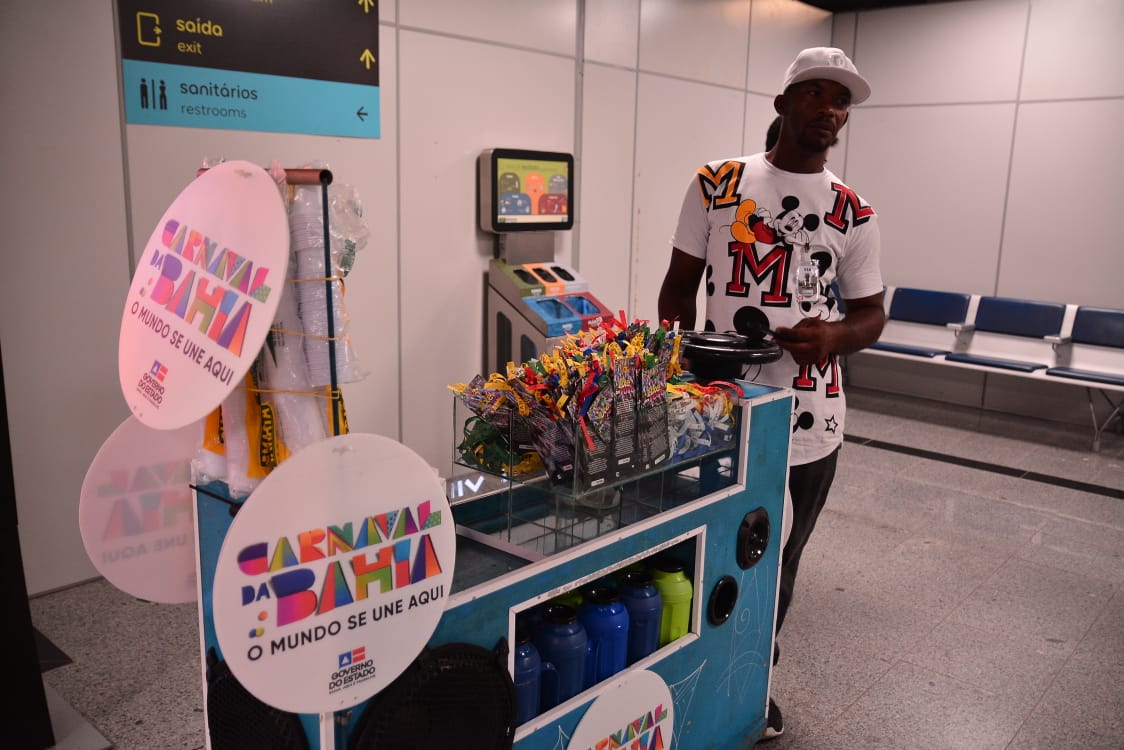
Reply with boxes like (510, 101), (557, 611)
(78, 417), (202, 604)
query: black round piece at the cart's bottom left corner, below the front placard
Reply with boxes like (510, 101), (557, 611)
(207, 649), (309, 750)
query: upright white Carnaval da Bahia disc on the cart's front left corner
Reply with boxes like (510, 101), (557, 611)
(211, 434), (456, 713)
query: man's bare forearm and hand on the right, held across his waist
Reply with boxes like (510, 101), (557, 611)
(777, 292), (886, 364)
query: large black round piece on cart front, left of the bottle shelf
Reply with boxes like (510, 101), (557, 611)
(347, 639), (516, 750)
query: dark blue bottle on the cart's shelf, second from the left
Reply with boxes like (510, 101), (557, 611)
(534, 604), (589, 711)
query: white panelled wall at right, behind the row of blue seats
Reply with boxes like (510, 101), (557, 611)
(845, 0), (1124, 424)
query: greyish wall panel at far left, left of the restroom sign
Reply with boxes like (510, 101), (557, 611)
(0, 0), (134, 594)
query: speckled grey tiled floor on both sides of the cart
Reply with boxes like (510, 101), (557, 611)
(31, 391), (1124, 750)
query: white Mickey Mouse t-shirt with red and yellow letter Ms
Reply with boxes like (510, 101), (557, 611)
(672, 154), (882, 466)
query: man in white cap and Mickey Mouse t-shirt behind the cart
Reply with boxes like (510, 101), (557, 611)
(659, 47), (886, 739)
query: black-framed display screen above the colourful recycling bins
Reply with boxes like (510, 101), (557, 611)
(480, 148), (573, 232)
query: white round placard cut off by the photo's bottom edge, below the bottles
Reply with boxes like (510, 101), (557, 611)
(566, 670), (676, 750)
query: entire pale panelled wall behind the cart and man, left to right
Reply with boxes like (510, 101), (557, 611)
(8, 0), (1124, 594)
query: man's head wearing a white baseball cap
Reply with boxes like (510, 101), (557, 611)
(773, 47), (870, 155)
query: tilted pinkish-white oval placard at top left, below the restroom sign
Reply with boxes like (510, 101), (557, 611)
(117, 161), (289, 430)
